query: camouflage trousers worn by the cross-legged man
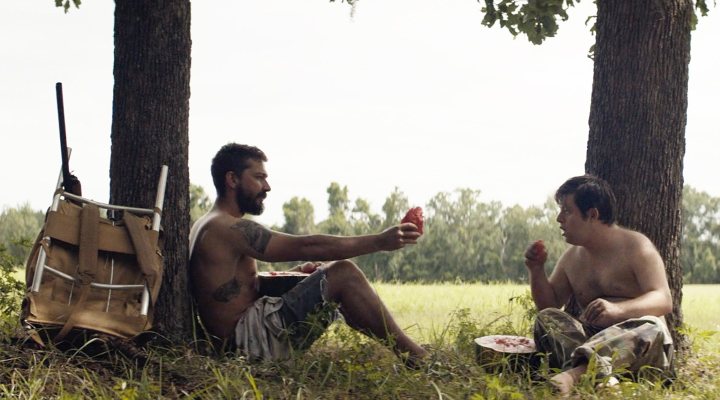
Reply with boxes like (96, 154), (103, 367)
(534, 308), (673, 376)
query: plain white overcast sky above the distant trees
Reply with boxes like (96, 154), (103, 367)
(0, 0), (720, 223)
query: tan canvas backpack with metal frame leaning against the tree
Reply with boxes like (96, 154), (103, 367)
(21, 198), (163, 345)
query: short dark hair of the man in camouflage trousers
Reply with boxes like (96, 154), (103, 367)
(555, 174), (617, 225)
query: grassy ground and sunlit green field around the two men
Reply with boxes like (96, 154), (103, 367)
(0, 283), (720, 400)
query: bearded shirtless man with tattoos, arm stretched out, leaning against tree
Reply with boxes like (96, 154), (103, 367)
(190, 143), (427, 363)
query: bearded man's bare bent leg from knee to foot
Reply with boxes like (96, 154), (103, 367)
(327, 260), (427, 360)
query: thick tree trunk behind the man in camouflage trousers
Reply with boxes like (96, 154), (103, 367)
(585, 0), (693, 349)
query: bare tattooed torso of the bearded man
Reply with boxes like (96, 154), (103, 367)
(190, 212), (259, 338)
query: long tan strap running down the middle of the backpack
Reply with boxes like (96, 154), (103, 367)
(54, 204), (100, 342)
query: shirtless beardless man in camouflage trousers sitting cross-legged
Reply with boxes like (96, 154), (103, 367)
(525, 175), (672, 394)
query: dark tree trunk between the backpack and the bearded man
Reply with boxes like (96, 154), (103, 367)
(110, 0), (191, 340)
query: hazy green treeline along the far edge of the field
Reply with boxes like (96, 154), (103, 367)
(0, 182), (720, 283)
